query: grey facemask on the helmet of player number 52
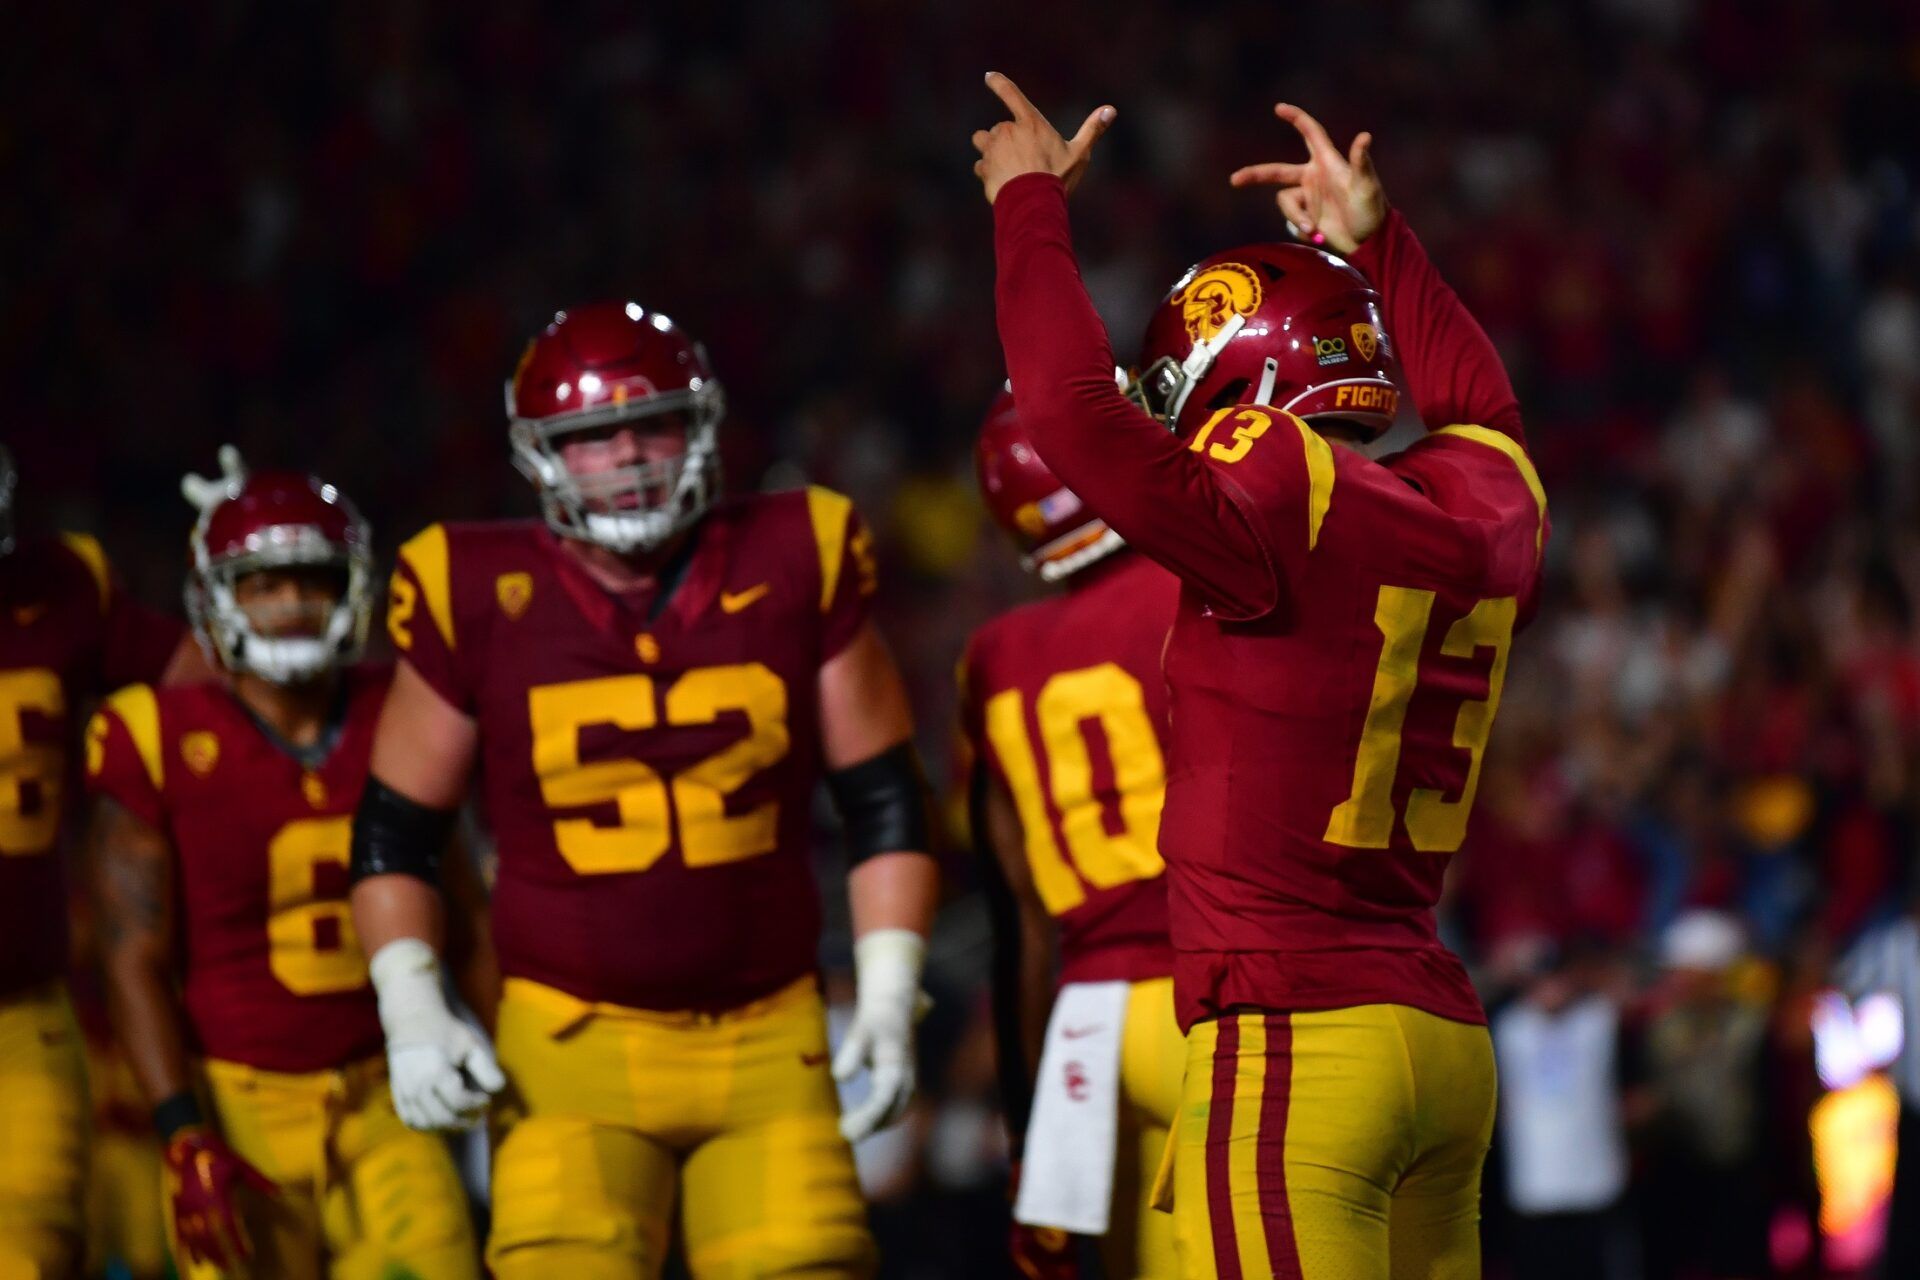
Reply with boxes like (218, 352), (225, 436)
(507, 378), (726, 555)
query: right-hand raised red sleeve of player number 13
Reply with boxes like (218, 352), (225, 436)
(1352, 209), (1526, 443)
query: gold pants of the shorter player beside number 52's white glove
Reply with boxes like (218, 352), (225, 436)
(165, 1059), (480, 1280)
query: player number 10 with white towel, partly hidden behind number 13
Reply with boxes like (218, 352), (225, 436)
(960, 391), (1187, 1280)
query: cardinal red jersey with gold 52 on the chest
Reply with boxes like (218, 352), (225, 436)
(388, 487), (876, 1009)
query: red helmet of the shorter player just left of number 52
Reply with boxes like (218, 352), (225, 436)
(180, 447), (372, 685)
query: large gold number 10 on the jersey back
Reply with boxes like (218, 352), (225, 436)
(985, 662), (1167, 915)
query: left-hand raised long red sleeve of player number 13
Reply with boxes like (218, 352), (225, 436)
(993, 175), (1279, 620)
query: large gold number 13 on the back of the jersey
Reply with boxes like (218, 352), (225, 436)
(1323, 587), (1515, 854)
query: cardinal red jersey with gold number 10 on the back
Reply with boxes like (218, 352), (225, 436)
(960, 553), (1179, 983)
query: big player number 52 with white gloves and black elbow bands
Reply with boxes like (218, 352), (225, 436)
(353, 303), (937, 1280)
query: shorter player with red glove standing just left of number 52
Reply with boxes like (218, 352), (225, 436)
(86, 453), (478, 1280)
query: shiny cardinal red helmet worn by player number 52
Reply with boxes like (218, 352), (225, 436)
(507, 301), (726, 553)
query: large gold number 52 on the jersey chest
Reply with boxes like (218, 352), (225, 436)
(526, 662), (789, 875)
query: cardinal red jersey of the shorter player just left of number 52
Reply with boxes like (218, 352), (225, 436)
(86, 666), (392, 1071)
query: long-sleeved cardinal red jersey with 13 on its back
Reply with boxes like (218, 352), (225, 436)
(995, 175), (1548, 1027)
